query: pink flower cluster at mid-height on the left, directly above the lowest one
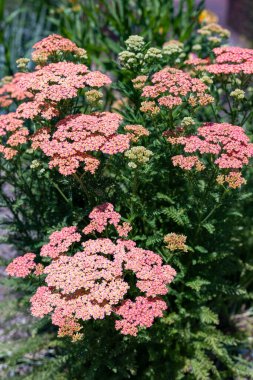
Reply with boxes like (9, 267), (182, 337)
(31, 112), (130, 175)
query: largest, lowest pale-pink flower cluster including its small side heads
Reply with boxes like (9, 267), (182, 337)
(7, 204), (176, 340)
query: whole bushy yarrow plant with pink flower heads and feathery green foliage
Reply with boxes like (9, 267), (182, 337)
(0, 20), (253, 380)
